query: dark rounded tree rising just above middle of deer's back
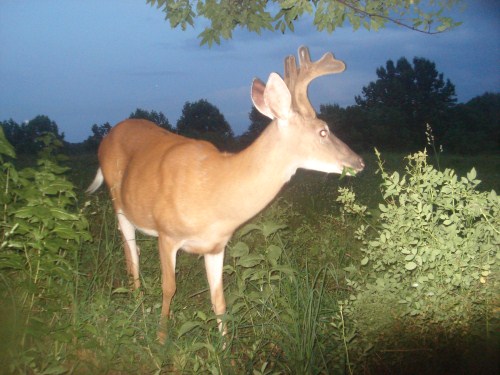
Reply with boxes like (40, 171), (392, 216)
(177, 99), (234, 150)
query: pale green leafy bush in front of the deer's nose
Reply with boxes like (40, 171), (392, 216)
(339, 151), (500, 339)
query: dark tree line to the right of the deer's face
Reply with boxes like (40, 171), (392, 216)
(319, 58), (500, 154)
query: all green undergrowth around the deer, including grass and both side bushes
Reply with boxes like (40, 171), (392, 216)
(0, 128), (500, 375)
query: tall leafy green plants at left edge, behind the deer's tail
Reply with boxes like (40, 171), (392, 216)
(0, 131), (90, 374)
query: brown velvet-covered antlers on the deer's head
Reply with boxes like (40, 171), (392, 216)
(285, 46), (345, 118)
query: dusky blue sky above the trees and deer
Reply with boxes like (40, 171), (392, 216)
(0, 0), (500, 142)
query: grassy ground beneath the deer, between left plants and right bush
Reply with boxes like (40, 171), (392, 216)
(0, 148), (500, 375)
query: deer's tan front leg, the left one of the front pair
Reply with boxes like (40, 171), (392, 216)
(158, 235), (178, 344)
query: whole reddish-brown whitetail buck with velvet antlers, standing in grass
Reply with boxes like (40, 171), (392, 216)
(87, 47), (364, 341)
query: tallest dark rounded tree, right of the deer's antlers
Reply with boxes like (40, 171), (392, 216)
(355, 57), (456, 148)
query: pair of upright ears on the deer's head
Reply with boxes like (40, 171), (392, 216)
(252, 73), (292, 120)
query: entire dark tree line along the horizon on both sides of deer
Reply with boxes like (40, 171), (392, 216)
(0, 57), (500, 154)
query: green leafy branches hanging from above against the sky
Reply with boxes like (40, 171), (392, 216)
(146, 0), (459, 46)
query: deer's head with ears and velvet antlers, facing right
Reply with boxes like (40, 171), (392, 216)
(252, 47), (364, 173)
